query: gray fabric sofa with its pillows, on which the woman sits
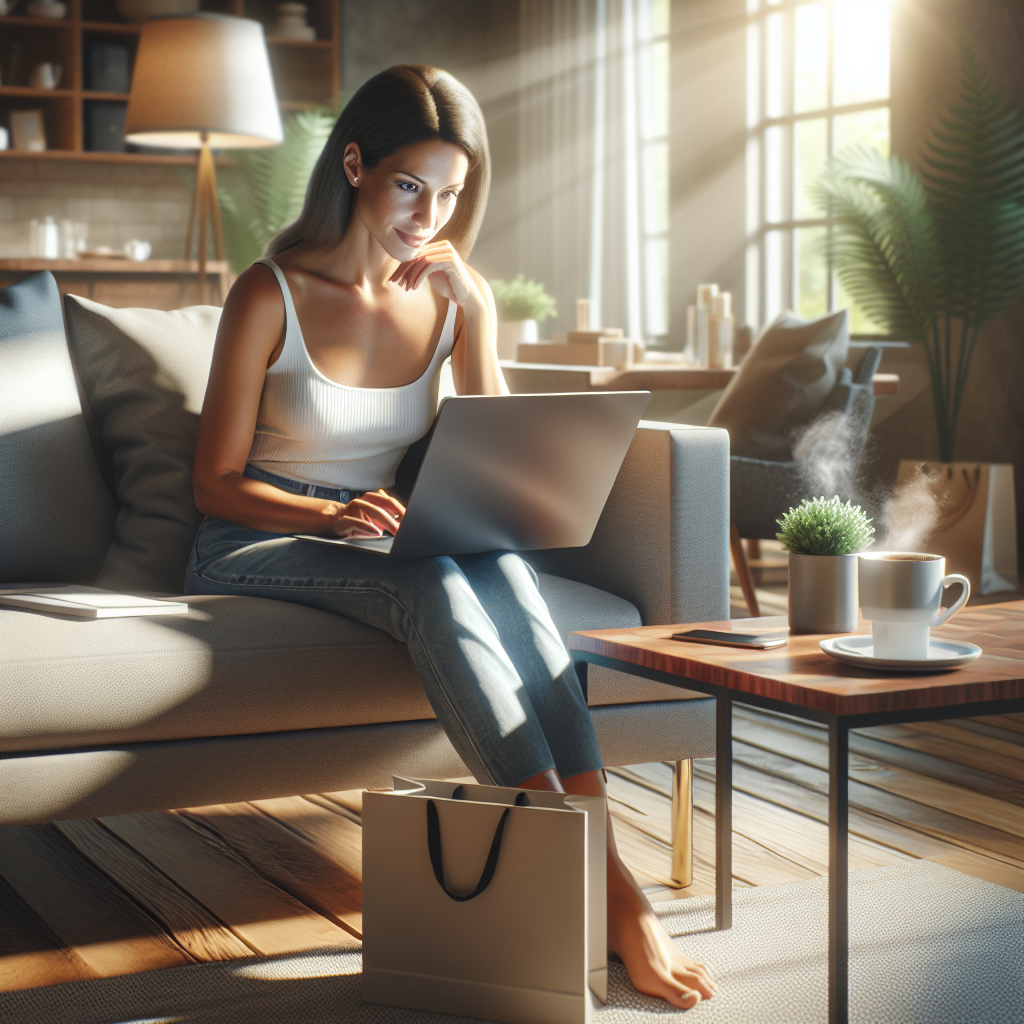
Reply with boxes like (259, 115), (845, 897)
(0, 273), (729, 839)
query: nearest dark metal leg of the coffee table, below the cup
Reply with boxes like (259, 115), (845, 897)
(828, 719), (850, 1024)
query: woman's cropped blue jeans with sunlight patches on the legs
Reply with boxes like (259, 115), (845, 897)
(185, 519), (602, 785)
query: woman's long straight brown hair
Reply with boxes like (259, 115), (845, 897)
(266, 65), (490, 259)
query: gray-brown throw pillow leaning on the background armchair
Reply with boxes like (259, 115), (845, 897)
(708, 309), (850, 462)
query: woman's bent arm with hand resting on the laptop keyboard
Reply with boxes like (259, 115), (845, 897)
(193, 265), (401, 537)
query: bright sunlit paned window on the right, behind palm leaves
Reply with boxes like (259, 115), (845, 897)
(745, 0), (891, 333)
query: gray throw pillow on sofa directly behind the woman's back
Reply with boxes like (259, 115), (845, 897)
(65, 295), (220, 594)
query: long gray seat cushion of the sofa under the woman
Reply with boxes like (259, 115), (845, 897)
(0, 577), (679, 752)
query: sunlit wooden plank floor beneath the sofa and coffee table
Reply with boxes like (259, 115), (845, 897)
(0, 707), (1024, 990)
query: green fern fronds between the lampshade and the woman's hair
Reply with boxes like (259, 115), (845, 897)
(218, 108), (337, 273)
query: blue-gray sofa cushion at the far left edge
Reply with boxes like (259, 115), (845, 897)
(0, 271), (114, 585)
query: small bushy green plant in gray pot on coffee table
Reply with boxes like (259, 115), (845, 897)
(775, 496), (874, 633)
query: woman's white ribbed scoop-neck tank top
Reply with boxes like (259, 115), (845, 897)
(243, 257), (457, 490)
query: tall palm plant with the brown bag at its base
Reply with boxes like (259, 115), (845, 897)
(812, 39), (1024, 593)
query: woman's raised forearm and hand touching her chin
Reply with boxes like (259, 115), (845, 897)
(391, 240), (509, 394)
